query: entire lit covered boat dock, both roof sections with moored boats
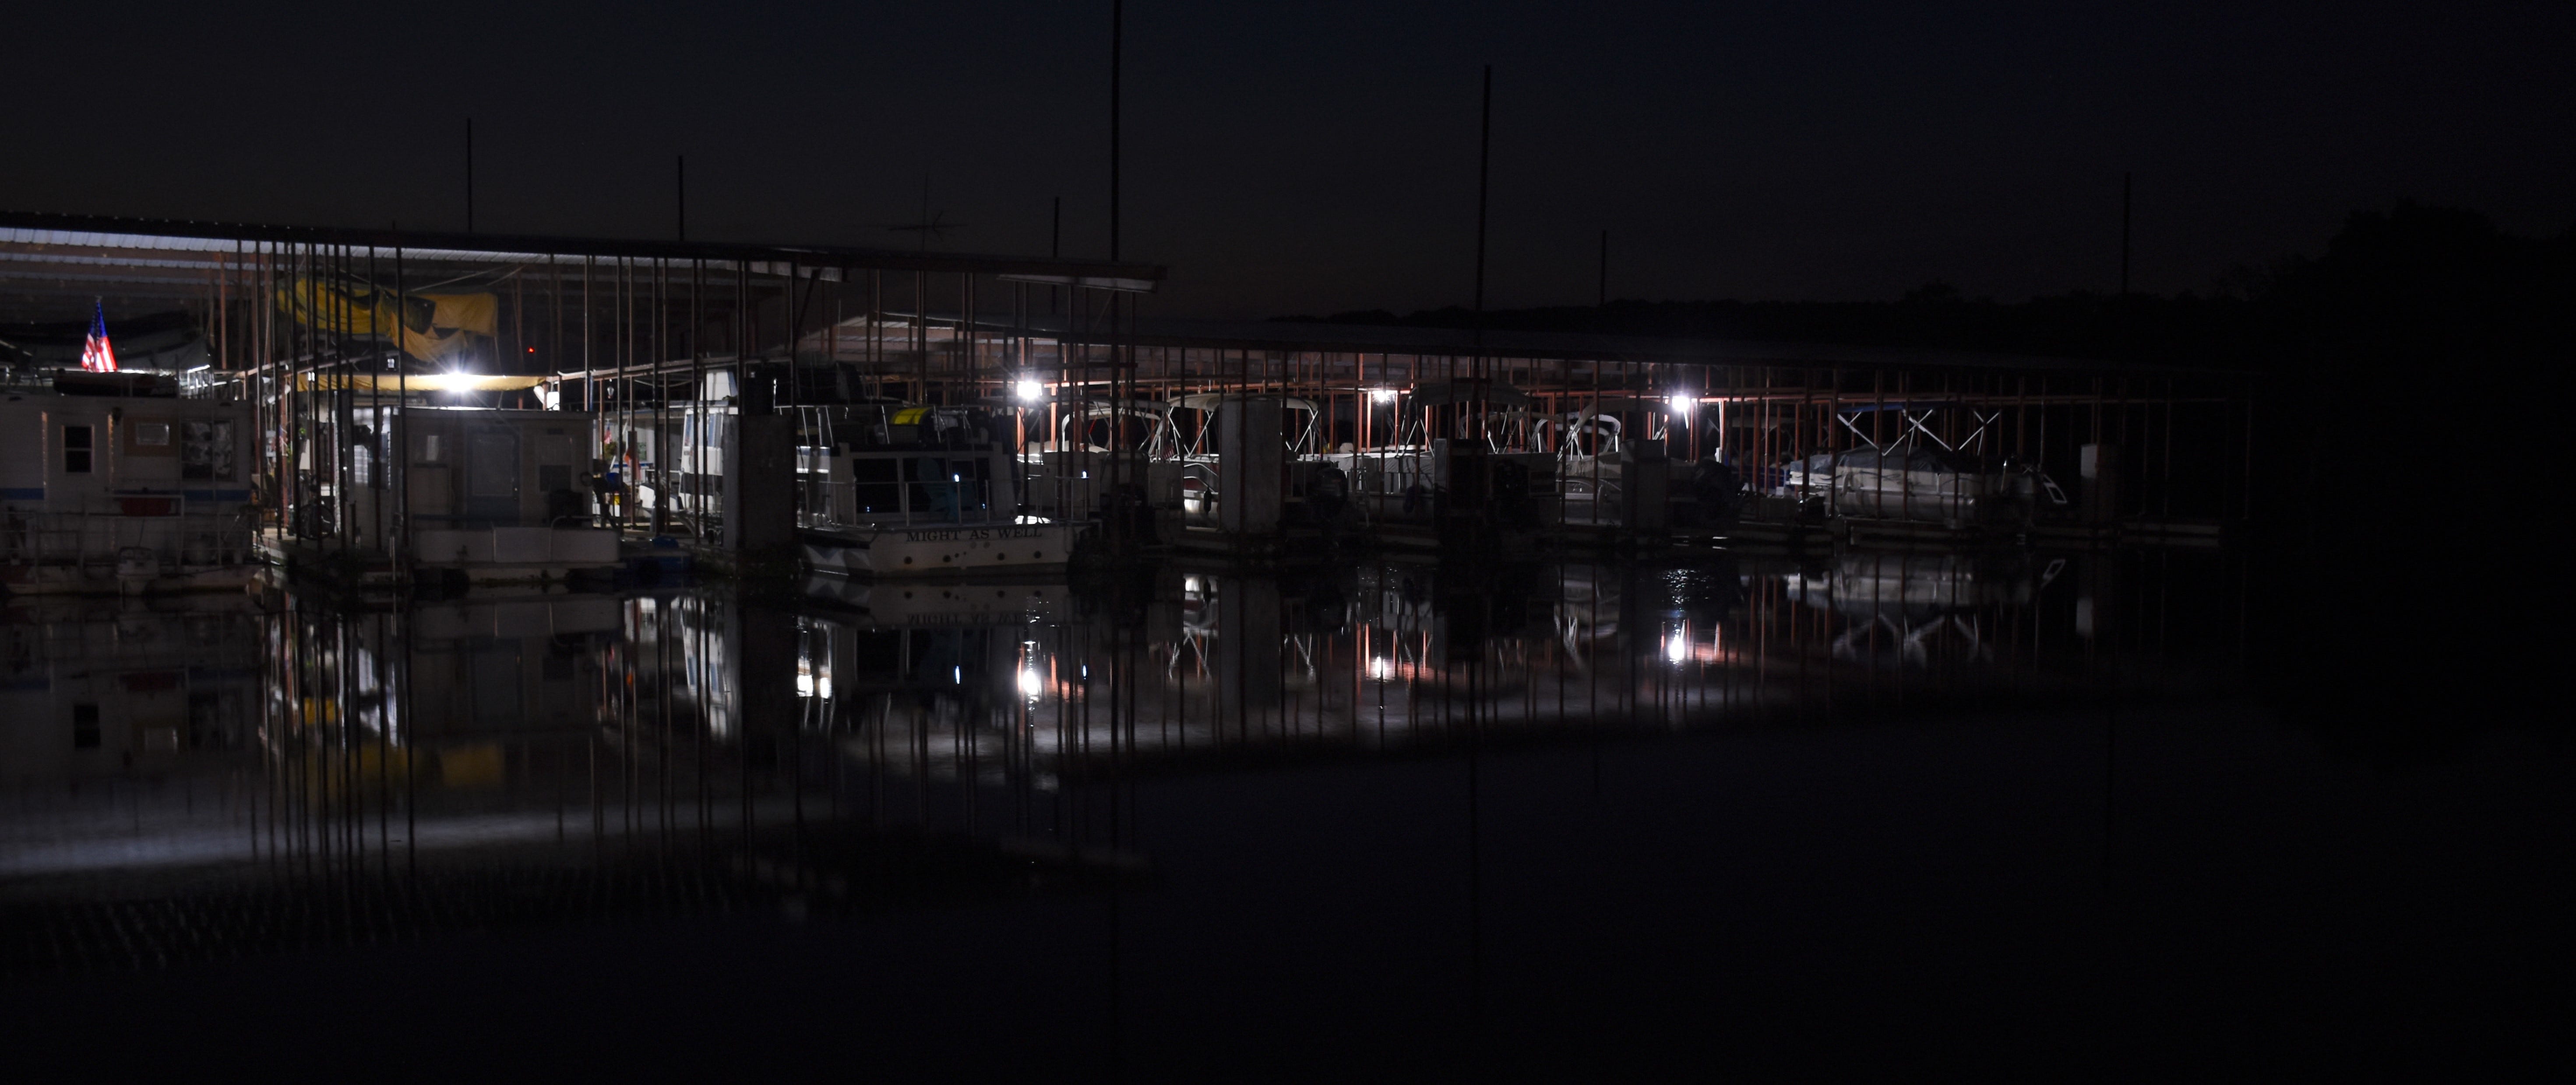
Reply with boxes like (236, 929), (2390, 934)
(0, 216), (2257, 585)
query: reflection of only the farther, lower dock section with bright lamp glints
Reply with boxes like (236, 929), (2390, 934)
(799, 554), (2223, 791)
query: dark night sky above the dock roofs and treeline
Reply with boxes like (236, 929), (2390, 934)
(0, 0), (2576, 317)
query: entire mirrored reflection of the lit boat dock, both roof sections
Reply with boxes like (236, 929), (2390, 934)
(0, 551), (2236, 972)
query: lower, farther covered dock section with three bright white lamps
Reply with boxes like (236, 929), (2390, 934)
(701, 304), (2254, 554)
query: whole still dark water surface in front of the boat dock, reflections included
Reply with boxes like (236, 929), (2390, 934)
(0, 551), (2571, 1077)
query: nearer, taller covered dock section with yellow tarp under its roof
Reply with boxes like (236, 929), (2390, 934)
(0, 214), (1162, 585)
